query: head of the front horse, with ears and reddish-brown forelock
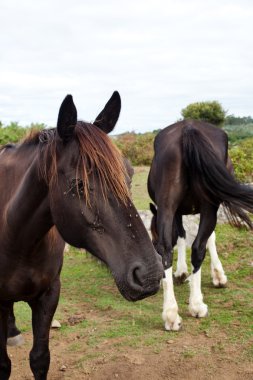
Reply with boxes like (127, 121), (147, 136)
(45, 92), (163, 301)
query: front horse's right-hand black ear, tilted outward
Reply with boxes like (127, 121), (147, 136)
(93, 91), (121, 133)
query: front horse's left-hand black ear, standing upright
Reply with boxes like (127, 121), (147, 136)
(57, 95), (77, 142)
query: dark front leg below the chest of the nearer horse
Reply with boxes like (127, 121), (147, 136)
(29, 278), (60, 380)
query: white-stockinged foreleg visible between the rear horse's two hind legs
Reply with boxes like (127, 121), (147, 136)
(174, 215), (188, 283)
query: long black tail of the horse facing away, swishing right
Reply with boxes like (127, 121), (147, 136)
(182, 126), (253, 229)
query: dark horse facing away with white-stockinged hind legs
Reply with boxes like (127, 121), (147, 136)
(148, 120), (253, 330)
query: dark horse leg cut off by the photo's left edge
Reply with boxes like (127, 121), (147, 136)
(0, 306), (11, 380)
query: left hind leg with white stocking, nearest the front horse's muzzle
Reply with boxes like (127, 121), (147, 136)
(158, 208), (182, 331)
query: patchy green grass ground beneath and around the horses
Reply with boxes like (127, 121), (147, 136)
(10, 168), (253, 379)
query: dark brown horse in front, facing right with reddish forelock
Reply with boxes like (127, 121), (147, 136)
(0, 92), (163, 380)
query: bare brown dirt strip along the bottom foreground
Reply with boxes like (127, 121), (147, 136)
(9, 331), (253, 380)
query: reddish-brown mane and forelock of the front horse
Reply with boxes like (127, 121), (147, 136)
(22, 121), (129, 205)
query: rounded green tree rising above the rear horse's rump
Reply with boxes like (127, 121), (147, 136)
(181, 100), (226, 126)
